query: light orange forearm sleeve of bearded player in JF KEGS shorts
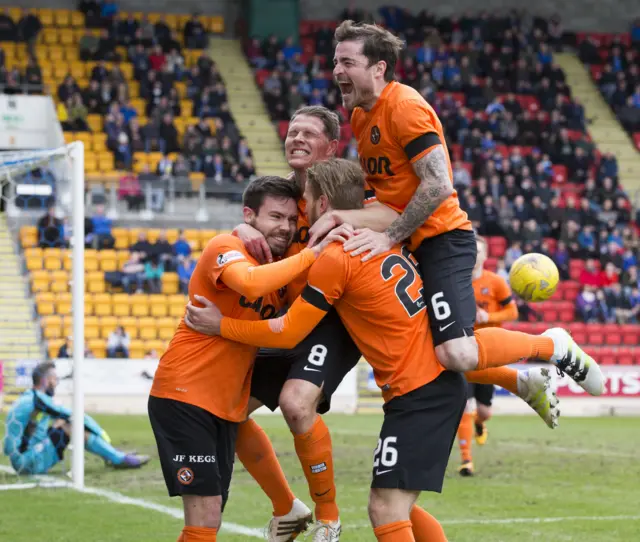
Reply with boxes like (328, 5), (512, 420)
(220, 248), (315, 299)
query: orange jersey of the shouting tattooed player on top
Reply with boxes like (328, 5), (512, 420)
(351, 81), (471, 251)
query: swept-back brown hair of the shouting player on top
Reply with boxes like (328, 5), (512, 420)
(334, 20), (404, 82)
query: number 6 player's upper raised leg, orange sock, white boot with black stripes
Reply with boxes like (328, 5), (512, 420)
(436, 327), (604, 396)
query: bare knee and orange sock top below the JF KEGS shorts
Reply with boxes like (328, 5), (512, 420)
(178, 495), (222, 542)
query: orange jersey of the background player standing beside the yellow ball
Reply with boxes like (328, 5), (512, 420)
(473, 269), (518, 329)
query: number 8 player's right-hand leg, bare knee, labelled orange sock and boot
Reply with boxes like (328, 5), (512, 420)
(280, 379), (341, 542)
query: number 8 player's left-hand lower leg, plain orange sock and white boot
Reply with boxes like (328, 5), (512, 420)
(236, 397), (312, 542)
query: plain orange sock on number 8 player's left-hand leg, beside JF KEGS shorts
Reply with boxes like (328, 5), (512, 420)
(236, 419), (295, 516)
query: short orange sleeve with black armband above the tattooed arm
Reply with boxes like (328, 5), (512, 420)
(391, 99), (443, 163)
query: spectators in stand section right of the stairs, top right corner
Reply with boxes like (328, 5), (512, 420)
(579, 19), (640, 142)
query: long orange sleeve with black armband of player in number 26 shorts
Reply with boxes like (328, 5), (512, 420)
(220, 249), (346, 348)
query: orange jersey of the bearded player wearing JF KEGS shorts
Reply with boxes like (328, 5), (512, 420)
(151, 235), (315, 422)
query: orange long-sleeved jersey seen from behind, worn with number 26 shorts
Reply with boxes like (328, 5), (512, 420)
(221, 243), (444, 401)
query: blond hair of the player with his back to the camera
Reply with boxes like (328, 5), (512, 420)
(307, 158), (365, 210)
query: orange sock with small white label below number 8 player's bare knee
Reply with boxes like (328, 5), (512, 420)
(293, 416), (339, 522)
